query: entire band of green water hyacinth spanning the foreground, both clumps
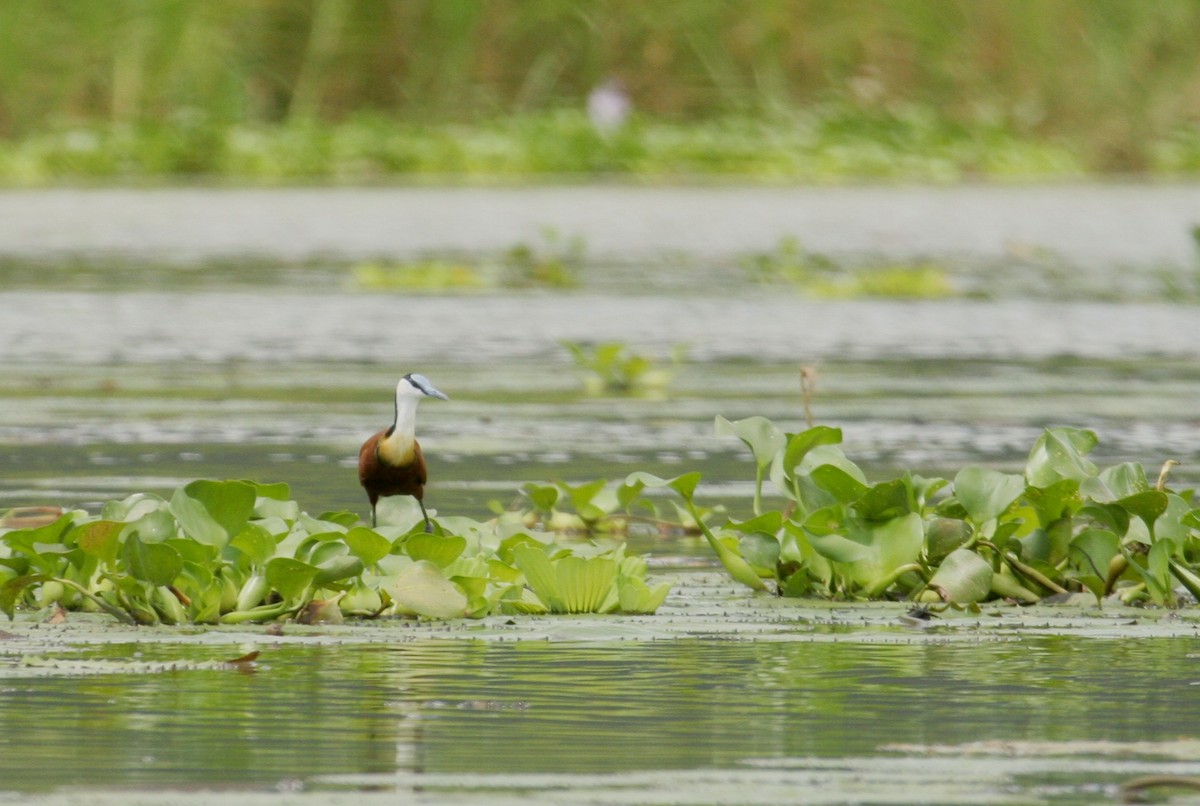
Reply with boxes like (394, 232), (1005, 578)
(9, 417), (1200, 624)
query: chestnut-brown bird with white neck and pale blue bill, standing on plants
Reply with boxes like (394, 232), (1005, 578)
(359, 372), (450, 533)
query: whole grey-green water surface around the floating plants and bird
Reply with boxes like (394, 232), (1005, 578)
(0, 188), (1200, 806)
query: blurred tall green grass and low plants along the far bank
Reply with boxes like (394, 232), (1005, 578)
(0, 0), (1200, 185)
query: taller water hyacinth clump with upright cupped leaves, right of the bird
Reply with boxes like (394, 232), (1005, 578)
(652, 417), (1200, 606)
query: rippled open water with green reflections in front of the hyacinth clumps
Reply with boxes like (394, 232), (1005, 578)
(0, 637), (1200, 790)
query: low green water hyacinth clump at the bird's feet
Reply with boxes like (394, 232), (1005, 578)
(0, 480), (670, 624)
